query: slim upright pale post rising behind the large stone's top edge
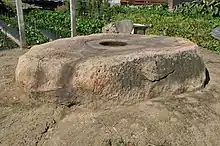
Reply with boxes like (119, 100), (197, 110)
(70, 0), (76, 37)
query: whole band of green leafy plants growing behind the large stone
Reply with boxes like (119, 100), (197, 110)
(0, 0), (220, 51)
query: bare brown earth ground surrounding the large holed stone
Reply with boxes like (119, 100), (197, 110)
(0, 49), (220, 146)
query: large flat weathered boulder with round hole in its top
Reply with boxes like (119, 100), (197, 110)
(16, 34), (206, 107)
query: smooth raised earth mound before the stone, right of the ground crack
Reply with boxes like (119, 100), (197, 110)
(43, 94), (220, 146)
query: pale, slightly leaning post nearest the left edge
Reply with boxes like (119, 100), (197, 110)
(15, 0), (26, 49)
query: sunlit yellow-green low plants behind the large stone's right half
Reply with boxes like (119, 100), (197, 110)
(112, 5), (220, 51)
